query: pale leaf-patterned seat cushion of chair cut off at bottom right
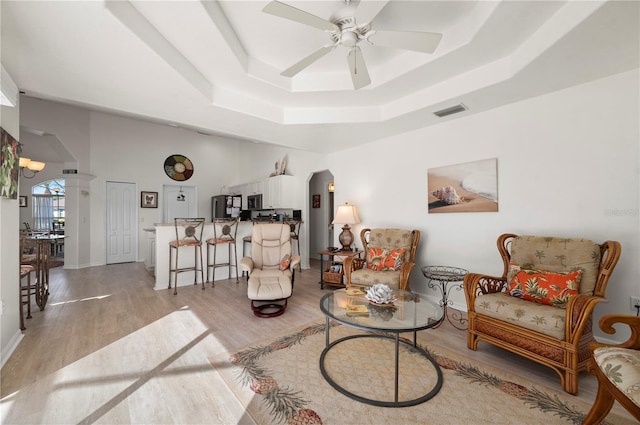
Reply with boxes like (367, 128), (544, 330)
(593, 347), (640, 407)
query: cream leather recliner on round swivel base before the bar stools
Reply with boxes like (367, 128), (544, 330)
(240, 223), (300, 317)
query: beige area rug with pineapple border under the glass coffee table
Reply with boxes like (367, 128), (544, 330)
(209, 322), (635, 425)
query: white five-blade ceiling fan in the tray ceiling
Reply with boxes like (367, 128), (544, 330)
(262, 0), (442, 90)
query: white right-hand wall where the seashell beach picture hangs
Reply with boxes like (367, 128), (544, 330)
(329, 70), (640, 342)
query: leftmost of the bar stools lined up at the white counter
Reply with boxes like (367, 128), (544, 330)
(168, 218), (204, 295)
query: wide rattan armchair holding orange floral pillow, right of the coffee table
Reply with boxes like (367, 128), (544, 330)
(464, 234), (621, 394)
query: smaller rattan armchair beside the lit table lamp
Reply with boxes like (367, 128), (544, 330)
(344, 229), (420, 291)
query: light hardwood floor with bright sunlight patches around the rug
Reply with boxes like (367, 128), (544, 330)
(0, 261), (624, 423)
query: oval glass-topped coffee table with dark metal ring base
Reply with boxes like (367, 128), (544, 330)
(320, 289), (443, 407)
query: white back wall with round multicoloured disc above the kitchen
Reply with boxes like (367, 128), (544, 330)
(85, 112), (325, 265)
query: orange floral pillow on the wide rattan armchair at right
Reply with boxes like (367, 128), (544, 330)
(507, 264), (582, 308)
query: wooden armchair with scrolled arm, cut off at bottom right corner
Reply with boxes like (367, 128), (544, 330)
(582, 314), (640, 425)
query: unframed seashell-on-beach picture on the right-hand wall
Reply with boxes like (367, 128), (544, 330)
(427, 158), (498, 213)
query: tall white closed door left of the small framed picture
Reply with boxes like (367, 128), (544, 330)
(106, 182), (138, 264)
